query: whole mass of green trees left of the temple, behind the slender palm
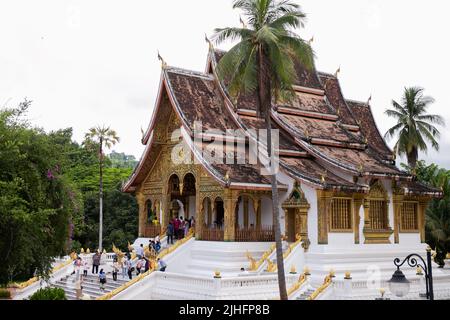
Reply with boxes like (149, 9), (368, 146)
(0, 101), (138, 285)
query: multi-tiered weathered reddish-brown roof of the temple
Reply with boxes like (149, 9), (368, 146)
(124, 47), (439, 195)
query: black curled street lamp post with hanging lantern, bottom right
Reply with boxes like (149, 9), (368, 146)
(389, 248), (434, 300)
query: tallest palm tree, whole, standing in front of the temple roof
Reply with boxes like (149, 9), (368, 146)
(214, 0), (314, 300)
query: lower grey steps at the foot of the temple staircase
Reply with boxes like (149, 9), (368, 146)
(52, 274), (128, 300)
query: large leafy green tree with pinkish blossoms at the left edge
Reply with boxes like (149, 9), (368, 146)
(0, 101), (82, 284)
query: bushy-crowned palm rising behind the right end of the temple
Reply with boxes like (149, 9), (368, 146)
(385, 87), (445, 170)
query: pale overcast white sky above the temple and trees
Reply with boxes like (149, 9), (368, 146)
(0, 0), (450, 168)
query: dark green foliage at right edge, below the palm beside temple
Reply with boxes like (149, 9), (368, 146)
(415, 161), (450, 265)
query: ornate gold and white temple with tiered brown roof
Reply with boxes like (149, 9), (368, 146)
(123, 46), (441, 250)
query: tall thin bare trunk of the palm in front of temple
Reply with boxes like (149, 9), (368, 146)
(258, 48), (288, 300)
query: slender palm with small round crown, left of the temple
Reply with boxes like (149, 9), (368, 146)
(85, 126), (120, 252)
